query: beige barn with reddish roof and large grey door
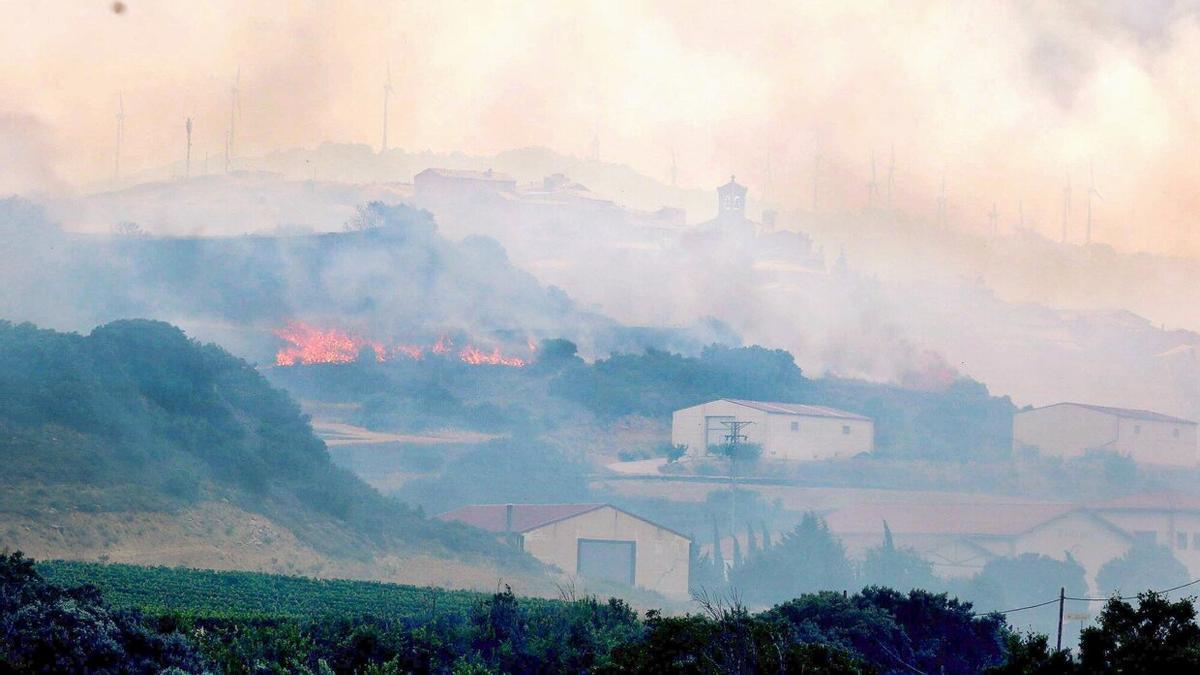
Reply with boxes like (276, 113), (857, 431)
(438, 504), (691, 598)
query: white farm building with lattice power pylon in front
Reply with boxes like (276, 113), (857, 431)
(671, 399), (875, 460)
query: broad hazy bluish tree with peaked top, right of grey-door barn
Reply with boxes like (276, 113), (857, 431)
(732, 513), (854, 604)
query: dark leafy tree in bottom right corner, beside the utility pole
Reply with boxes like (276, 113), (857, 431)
(1079, 592), (1200, 673)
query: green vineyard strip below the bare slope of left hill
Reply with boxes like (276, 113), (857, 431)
(37, 561), (550, 619)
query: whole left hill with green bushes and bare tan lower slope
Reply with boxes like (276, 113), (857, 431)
(0, 321), (539, 585)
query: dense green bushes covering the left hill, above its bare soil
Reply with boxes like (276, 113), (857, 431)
(0, 321), (523, 561)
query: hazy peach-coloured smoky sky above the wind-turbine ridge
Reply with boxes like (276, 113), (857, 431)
(0, 0), (1200, 255)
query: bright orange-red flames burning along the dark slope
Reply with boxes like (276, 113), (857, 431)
(275, 321), (533, 368)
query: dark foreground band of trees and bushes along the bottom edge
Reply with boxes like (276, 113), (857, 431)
(11, 554), (1200, 675)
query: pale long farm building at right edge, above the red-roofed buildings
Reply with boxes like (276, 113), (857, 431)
(1013, 404), (1198, 465)
